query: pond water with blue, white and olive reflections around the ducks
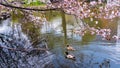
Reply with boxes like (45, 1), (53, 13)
(0, 11), (120, 68)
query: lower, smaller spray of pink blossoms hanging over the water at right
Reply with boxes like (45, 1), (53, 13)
(74, 27), (120, 41)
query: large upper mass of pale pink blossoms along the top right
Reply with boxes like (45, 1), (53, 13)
(48, 0), (120, 19)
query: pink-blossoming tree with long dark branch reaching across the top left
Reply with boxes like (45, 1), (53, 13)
(0, 0), (120, 37)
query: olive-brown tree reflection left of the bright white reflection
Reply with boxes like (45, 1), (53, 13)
(12, 10), (42, 45)
